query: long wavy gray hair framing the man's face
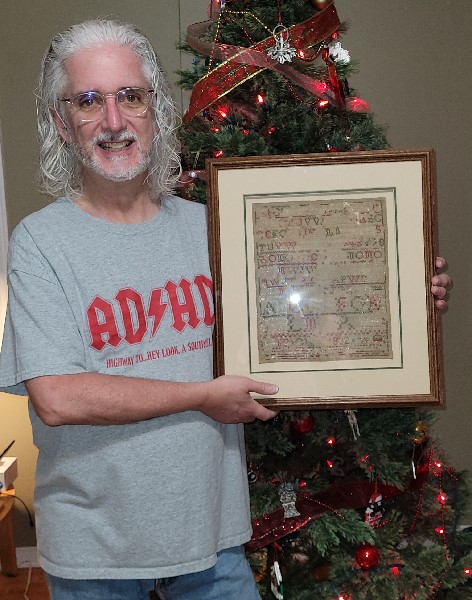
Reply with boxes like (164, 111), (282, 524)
(36, 19), (180, 200)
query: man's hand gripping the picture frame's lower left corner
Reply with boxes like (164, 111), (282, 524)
(200, 375), (278, 423)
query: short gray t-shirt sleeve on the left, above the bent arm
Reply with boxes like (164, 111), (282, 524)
(0, 225), (86, 395)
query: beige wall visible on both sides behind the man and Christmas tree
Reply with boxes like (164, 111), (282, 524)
(0, 0), (472, 546)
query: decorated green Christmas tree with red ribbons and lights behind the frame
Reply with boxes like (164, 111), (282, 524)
(174, 0), (472, 600)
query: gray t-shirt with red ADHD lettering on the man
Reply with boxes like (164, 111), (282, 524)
(0, 197), (251, 579)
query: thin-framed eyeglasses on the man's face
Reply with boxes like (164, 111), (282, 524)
(61, 88), (154, 122)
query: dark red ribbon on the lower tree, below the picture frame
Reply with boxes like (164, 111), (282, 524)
(246, 465), (429, 552)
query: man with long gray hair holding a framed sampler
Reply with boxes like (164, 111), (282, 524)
(0, 21), (449, 600)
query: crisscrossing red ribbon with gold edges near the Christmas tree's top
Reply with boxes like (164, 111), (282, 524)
(183, 3), (340, 123)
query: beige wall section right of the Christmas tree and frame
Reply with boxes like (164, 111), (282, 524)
(336, 0), (472, 502)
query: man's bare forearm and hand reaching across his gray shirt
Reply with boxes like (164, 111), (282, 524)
(25, 373), (277, 426)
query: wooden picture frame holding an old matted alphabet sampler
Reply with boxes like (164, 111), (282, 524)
(207, 150), (444, 410)
